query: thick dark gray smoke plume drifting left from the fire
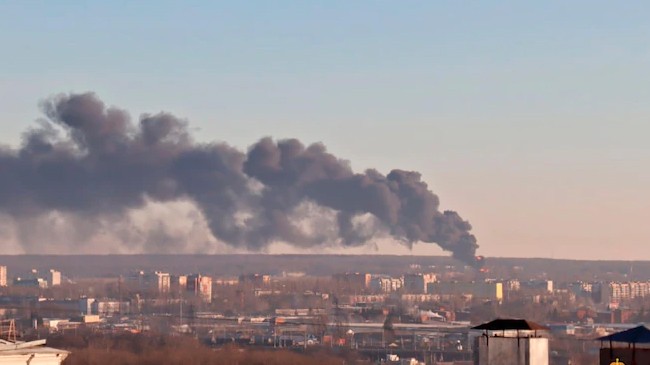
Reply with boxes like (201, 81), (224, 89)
(0, 93), (478, 263)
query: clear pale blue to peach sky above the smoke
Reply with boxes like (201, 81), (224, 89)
(0, 0), (650, 260)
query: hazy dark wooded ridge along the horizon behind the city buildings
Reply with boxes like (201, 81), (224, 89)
(0, 254), (650, 281)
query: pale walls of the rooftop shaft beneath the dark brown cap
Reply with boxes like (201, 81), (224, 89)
(475, 336), (548, 365)
